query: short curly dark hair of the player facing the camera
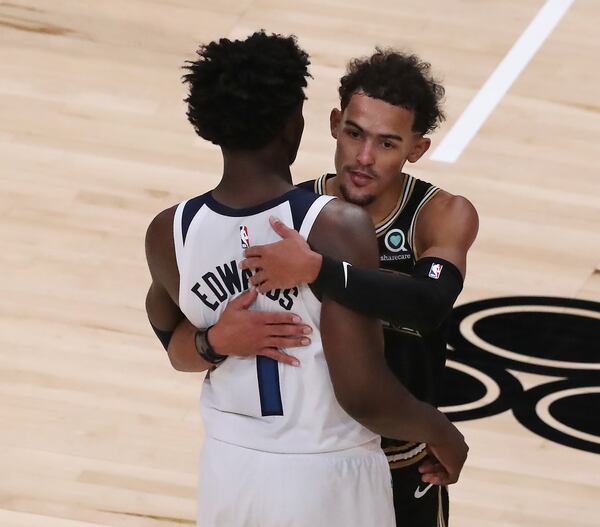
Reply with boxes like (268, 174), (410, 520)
(339, 48), (446, 134)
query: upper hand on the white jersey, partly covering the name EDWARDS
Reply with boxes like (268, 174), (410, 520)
(240, 218), (322, 293)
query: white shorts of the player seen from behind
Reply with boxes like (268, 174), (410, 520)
(197, 437), (395, 527)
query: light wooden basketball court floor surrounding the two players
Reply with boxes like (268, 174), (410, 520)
(0, 0), (600, 527)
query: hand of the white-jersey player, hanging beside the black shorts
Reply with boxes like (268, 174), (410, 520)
(419, 425), (469, 485)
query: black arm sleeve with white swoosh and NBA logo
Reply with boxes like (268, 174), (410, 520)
(314, 256), (463, 333)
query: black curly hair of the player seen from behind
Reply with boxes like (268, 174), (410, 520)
(183, 30), (310, 150)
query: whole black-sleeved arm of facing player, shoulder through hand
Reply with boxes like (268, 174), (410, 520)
(242, 193), (478, 332)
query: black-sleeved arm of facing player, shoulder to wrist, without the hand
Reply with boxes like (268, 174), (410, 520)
(316, 195), (478, 332)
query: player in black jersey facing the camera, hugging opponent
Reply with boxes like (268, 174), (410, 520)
(237, 50), (478, 527)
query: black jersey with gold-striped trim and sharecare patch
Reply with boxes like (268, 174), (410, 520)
(300, 174), (447, 466)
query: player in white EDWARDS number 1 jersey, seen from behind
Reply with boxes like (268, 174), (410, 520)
(146, 32), (467, 527)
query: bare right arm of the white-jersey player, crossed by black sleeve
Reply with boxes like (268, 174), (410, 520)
(310, 200), (467, 483)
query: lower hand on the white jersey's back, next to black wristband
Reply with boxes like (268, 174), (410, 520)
(208, 289), (312, 366)
